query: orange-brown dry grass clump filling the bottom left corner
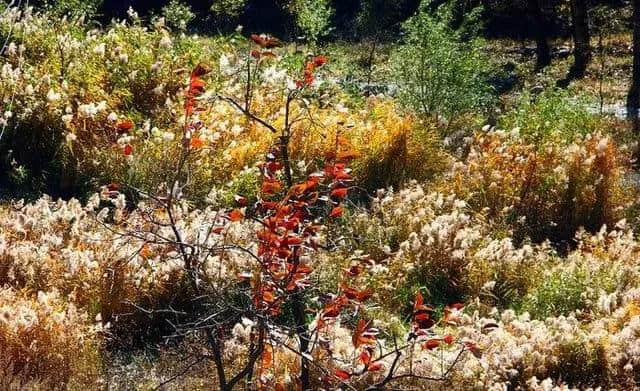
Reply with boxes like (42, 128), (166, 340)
(0, 287), (101, 389)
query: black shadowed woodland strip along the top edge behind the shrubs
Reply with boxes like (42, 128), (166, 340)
(32, 0), (629, 40)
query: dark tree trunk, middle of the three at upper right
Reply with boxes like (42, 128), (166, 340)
(568, 0), (591, 79)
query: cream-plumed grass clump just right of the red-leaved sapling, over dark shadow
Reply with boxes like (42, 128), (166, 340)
(340, 183), (555, 310)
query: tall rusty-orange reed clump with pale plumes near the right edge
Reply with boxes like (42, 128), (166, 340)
(442, 130), (637, 243)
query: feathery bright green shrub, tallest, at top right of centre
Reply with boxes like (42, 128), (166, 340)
(393, 0), (495, 128)
